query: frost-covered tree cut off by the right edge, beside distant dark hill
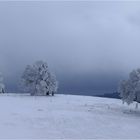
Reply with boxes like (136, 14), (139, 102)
(119, 69), (140, 106)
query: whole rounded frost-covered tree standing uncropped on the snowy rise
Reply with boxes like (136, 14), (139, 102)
(22, 61), (58, 95)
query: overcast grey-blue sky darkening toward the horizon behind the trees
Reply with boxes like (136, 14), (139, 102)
(0, 1), (140, 94)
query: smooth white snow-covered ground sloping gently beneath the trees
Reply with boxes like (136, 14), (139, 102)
(0, 94), (140, 139)
